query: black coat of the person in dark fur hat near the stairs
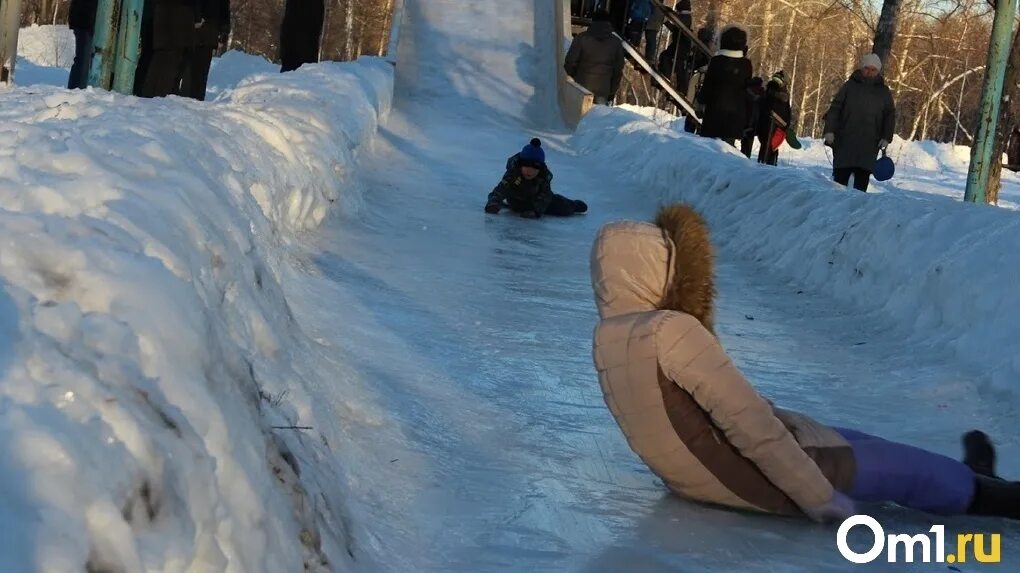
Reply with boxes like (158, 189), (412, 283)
(698, 50), (753, 140)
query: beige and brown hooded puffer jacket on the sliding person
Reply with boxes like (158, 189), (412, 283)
(592, 205), (855, 515)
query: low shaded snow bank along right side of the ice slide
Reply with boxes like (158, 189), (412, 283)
(574, 106), (1020, 388)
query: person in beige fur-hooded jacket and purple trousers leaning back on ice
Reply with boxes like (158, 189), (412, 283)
(591, 205), (1020, 522)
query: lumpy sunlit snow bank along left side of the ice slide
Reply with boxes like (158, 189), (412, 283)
(0, 59), (393, 573)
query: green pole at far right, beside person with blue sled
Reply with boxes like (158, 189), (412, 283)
(963, 0), (1016, 203)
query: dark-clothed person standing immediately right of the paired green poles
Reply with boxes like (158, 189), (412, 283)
(135, 0), (202, 98)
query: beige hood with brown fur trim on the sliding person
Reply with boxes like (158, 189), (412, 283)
(592, 204), (715, 332)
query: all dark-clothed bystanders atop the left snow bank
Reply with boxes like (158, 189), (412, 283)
(67, 0), (325, 100)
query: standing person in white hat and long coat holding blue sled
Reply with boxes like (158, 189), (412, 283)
(824, 54), (896, 192)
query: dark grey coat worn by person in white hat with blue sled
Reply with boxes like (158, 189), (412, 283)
(825, 70), (896, 171)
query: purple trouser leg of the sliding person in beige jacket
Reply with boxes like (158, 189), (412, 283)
(832, 428), (974, 515)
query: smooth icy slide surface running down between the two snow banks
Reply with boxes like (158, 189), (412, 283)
(298, 0), (1020, 573)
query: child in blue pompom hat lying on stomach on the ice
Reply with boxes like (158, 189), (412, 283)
(486, 138), (588, 219)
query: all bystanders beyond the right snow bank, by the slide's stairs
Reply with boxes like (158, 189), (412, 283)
(563, 0), (896, 192)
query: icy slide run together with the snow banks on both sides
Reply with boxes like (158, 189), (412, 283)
(0, 8), (1020, 573)
